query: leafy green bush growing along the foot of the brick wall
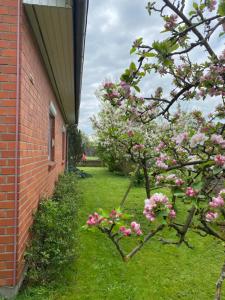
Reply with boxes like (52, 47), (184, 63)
(25, 173), (79, 284)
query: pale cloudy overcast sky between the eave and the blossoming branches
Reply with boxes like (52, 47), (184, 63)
(79, 0), (224, 134)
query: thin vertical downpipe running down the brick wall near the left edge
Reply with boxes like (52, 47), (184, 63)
(13, 0), (21, 286)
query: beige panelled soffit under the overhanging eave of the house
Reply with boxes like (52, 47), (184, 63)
(23, 0), (75, 123)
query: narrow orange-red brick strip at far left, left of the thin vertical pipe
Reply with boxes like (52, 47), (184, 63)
(0, 0), (17, 286)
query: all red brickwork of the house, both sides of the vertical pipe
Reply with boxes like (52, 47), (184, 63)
(0, 0), (65, 286)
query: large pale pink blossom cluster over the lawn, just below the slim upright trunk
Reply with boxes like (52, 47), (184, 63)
(143, 193), (176, 222)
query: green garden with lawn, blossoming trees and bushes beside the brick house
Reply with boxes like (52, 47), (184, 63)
(15, 0), (225, 300)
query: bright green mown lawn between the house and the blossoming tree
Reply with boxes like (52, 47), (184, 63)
(17, 168), (225, 300)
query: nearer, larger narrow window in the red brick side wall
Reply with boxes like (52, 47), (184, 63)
(48, 102), (56, 161)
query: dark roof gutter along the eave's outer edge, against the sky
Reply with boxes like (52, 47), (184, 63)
(72, 0), (89, 125)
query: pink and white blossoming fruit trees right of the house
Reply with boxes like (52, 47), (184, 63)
(86, 0), (225, 299)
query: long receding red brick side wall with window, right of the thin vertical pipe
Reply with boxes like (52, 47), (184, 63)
(18, 6), (64, 284)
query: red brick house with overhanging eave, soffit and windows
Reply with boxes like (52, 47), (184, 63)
(0, 0), (88, 296)
